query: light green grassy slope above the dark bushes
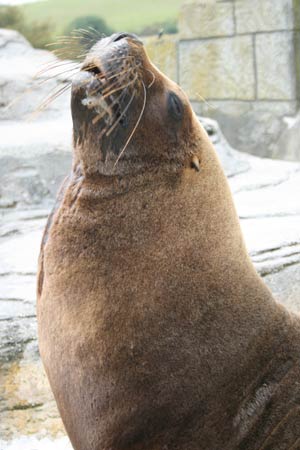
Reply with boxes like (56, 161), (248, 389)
(21, 0), (182, 35)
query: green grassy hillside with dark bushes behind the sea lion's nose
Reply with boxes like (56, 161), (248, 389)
(0, 0), (182, 50)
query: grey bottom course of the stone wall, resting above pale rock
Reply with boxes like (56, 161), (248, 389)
(193, 100), (300, 161)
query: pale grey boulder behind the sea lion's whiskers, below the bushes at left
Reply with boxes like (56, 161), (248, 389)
(0, 29), (75, 120)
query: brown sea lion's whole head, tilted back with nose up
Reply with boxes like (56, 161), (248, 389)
(72, 33), (200, 176)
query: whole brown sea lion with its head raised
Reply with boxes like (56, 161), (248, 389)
(38, 33), (300, 450)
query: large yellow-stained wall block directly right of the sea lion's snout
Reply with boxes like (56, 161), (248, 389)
(179, 36), (255, 101)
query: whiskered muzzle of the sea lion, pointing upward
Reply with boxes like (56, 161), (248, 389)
(72, 33), (142, 166)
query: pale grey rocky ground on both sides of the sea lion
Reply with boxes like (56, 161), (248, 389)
(0, 30), (300, 450)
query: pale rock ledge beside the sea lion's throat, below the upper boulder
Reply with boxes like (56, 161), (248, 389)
(0, 118), (72, 208)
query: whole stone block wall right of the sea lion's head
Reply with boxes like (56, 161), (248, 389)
(146, 0), (300, 159)
